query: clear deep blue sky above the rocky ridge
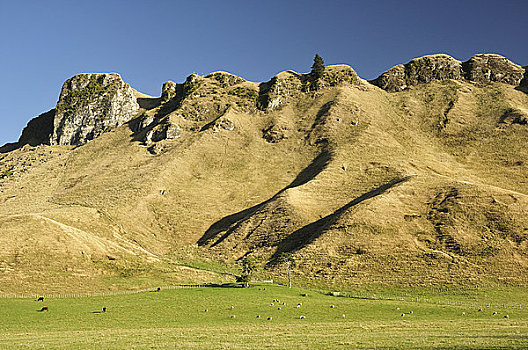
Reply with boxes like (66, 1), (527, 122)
(0, 0), (528, 145)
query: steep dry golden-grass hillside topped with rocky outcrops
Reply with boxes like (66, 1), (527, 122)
(0, 55), (528, 292)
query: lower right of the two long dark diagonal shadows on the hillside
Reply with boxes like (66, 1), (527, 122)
(268, 176), (410, 265)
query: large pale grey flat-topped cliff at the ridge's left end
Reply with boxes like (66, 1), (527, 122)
(51, 73), (139, 145)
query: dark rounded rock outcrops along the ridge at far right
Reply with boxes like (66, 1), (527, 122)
(371, 54), (525, 92)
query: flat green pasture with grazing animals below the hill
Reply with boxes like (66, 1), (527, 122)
(0, 285), (528, 349)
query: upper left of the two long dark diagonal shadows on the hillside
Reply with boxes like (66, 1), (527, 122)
(198, 150), (331, 246)
